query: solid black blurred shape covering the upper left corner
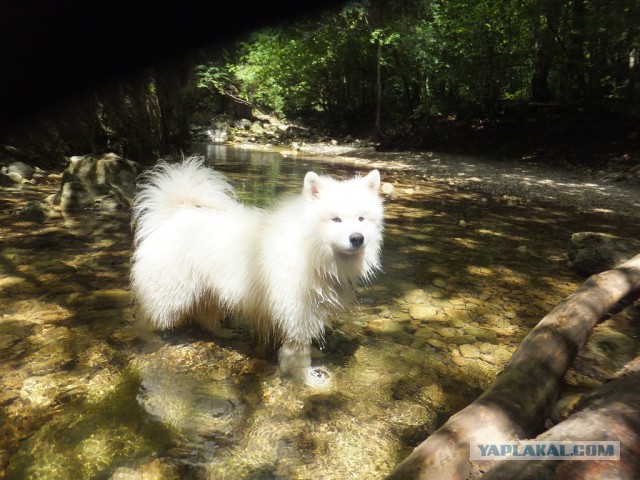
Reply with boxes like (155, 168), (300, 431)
(0, 0), (341, 128)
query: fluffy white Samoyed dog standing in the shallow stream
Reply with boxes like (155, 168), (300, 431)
(131, 157), (383, 385)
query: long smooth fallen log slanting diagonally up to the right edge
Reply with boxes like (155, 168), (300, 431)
(387, 255), (640, 480)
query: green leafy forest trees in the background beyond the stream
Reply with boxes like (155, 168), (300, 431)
(196, 0), (640, 131)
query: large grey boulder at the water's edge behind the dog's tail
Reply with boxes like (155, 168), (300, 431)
(53, 153), (142, 211)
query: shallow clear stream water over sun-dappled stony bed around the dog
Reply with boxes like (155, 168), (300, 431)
(0, 144), (635, 479)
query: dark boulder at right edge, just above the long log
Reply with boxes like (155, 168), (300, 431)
(569, 232), (640, 276)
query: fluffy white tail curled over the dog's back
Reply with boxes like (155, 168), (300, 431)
(131, 156), (235, 244)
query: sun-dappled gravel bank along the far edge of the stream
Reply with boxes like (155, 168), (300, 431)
(302, 144), (640, 219)
